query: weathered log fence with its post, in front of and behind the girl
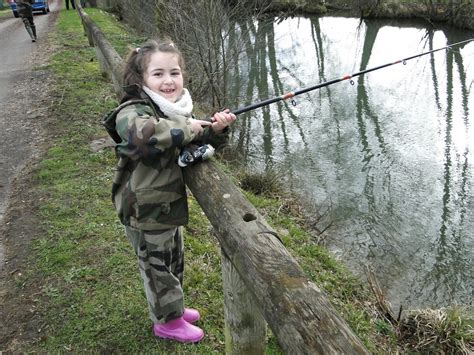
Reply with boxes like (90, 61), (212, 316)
(76, 4), (368, 354)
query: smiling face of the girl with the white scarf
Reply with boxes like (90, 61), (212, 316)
(144, 52), (184, 102)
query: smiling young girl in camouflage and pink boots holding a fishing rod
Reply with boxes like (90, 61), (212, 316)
(104, 40), (236, 342)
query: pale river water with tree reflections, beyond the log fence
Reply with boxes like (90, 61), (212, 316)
(227, 16), (474, 311)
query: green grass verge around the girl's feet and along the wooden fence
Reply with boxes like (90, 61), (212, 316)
(17, 8), (400, 354)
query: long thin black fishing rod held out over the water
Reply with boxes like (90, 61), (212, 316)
(231, 38), (474, 115)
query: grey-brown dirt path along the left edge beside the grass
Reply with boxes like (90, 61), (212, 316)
(0, 0), (62, 353)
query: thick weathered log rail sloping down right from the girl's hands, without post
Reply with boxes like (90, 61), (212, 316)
(183, 161), (368, 355)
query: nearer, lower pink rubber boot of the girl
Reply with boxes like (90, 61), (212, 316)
(153, 317), (204, 343)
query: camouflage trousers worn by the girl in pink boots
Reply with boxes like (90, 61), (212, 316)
(125, 227), (184, 323)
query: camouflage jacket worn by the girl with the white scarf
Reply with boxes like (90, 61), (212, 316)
(103, 95), (196, 230)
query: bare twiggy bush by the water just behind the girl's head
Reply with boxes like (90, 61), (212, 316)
(156, 0), (271, 109)
